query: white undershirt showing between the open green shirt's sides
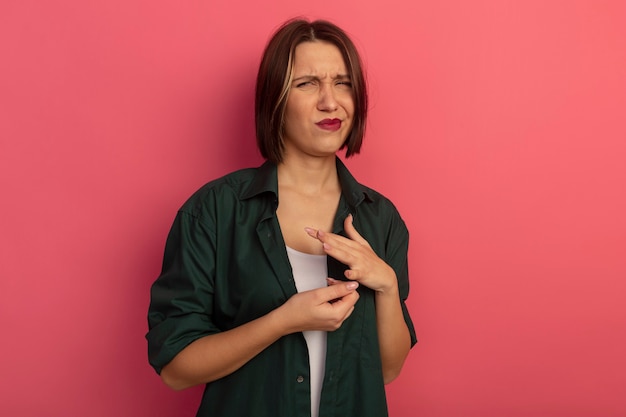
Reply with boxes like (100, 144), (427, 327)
(287, 247), (328, 417)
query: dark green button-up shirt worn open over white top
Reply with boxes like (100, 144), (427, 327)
(146, 159), (416, 417)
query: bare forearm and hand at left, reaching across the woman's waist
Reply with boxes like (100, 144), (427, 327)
(161, 282), (359, 390)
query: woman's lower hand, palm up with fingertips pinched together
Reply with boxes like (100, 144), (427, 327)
(274, 280), (359, 334)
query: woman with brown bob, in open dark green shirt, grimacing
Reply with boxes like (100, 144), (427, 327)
(146, 20), (416, 417)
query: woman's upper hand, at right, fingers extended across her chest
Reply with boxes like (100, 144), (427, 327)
(305, 215), (397, 293)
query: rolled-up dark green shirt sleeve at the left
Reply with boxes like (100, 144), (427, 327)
(146, 211), (220, 374)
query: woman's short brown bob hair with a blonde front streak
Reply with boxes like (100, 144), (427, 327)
(255, 19), (367, 164)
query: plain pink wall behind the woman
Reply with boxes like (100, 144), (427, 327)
(0, 0), (626, 417)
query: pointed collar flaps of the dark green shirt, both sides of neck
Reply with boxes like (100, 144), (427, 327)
(240, 158), (372, 207)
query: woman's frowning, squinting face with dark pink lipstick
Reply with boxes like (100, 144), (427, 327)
(283, 41), (354, 158)
